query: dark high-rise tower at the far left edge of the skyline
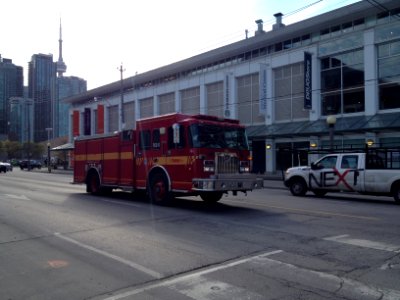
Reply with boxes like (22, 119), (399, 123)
(0, 55), (24, 140)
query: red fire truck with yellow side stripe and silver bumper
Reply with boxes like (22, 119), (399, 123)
(74, 113), (263, 204)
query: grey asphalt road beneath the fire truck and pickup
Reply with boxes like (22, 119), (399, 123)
(0, 169), (400, 300)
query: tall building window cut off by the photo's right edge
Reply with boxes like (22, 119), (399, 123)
(378, 41), (400, 109)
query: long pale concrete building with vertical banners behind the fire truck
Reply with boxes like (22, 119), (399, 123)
(66, 0), (400, 173)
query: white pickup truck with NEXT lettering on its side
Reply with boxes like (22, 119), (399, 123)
(284, 150), (400, 204)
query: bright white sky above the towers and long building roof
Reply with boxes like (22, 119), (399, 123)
(0, 0), (358, 90)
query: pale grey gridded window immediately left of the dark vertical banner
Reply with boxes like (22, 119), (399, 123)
(274, 63), (308, 121)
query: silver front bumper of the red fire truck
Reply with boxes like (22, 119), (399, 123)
(192, 174), (264, 192)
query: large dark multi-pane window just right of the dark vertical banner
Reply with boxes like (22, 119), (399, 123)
(321, 50), (365, 115)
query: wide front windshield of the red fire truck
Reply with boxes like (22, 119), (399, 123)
(189, 124), (249, 150)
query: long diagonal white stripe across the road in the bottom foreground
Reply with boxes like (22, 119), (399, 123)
(104, 250), (282, 300)
